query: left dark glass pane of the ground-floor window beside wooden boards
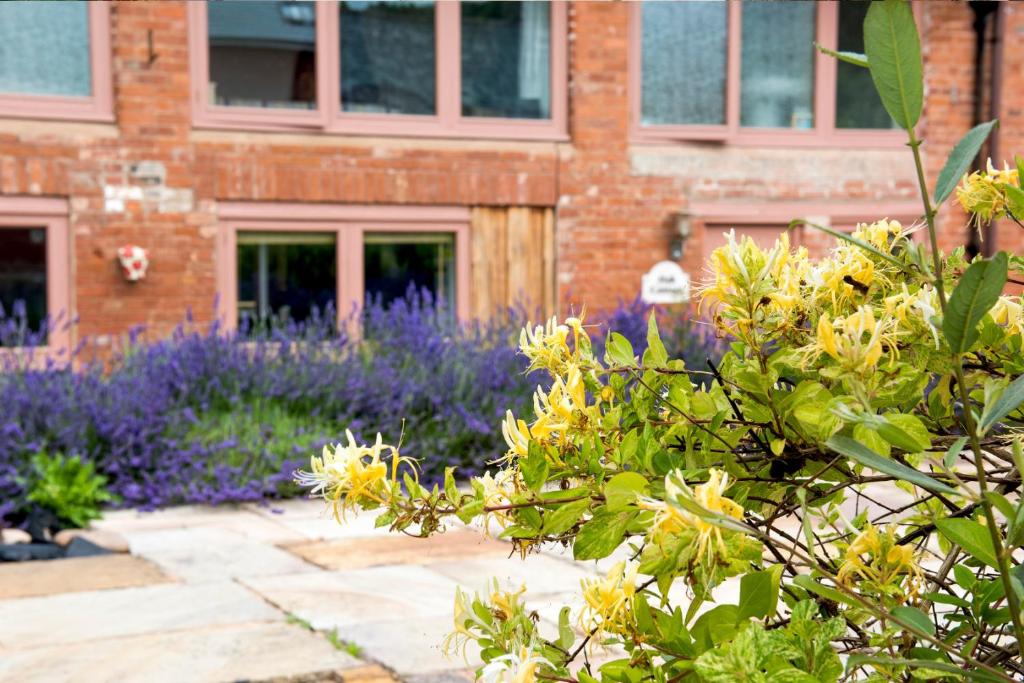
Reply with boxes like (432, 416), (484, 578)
(238, 232), (338, 326)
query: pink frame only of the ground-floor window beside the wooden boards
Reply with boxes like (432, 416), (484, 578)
(216, 202), (470, 330)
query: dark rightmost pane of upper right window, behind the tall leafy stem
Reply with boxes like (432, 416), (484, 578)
(836, 1), (896, 128)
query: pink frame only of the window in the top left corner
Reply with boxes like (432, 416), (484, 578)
(0, 2), (114, 122)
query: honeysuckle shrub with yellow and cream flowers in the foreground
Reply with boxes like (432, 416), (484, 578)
(298, 0), (1024, 683)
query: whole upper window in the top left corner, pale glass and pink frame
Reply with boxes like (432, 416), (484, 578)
(0, 0), (113, 121)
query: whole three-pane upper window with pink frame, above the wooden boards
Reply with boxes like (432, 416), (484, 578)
(188, 0), (567, 139)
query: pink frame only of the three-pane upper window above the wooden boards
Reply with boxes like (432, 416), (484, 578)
(188, 0), (568, 140)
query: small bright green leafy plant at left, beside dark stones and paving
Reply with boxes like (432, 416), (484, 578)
(28, 453), (114, 527)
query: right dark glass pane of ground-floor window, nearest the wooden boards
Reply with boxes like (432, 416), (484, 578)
(362, 232), (455, 307)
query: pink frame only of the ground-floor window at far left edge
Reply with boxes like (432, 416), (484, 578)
(0, 197), (75, 368)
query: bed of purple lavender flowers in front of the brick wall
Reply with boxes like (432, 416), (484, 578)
(0, 293), (720, 523)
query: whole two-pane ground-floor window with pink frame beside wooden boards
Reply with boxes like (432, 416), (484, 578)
(217, 203), (469, 326)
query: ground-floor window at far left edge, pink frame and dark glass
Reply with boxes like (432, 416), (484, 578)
(0, 198), (71, 361)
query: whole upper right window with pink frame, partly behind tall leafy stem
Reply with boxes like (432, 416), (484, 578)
(630, 0), (900, 145)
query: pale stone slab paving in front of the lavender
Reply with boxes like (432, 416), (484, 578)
(0, 501), (606, 683)
